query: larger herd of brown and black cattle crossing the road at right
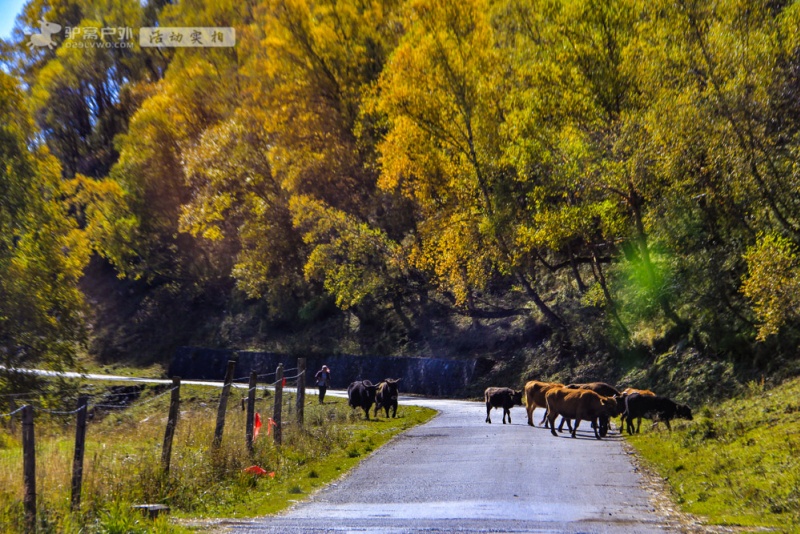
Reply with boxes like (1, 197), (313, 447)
(484, 380), (692, 439)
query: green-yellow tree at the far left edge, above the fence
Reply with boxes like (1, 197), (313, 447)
(0, 72), (89, 382)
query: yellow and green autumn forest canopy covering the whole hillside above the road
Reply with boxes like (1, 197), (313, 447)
(0, 0), (800, 376)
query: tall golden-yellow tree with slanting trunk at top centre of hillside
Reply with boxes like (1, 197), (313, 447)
(375, 1), (563, 326)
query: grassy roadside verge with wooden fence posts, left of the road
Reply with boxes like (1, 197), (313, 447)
(0, 386), (435, 534)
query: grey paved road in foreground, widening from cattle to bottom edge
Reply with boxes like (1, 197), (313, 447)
(219, 399), (670, 534)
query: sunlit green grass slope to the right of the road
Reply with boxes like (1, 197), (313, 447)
(629, 379), (800, 532)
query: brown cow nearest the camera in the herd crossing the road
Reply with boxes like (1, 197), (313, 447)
(545, 388), (618, 439)
